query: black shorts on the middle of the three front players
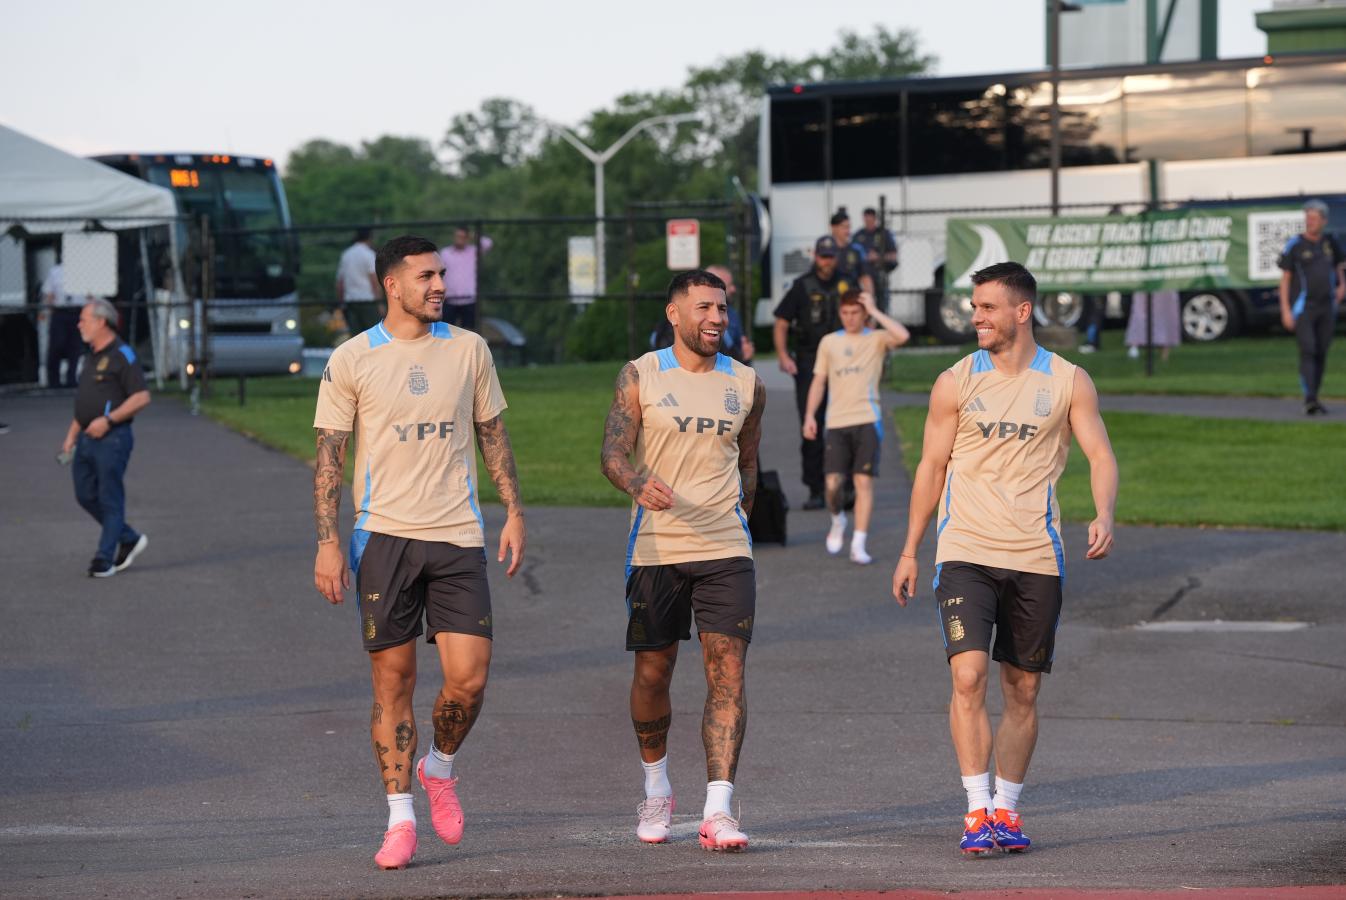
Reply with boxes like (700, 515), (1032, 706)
(626, 556), (756, 650)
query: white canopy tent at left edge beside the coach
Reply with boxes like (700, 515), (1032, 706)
(0, 125), (182, 383)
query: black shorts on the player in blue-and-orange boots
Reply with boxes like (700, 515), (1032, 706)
(934, 561), (1061, 673)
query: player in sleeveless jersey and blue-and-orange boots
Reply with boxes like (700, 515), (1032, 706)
(892, 262), (1117, 854)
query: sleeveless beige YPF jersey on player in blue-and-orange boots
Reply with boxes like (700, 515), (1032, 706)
(935, 347), (1075, 578)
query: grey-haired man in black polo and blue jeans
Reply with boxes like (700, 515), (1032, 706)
(61, 299), (149, 578)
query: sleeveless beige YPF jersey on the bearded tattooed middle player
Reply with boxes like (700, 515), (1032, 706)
(626, 347), (756, 574)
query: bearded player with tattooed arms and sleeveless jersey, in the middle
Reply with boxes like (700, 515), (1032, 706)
(602, 269), (766, 850)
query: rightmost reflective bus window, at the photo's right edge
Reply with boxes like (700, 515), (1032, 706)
(1248, 63), (1346, 156)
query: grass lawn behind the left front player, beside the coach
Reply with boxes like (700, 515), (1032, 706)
(202, 363), (630, 510)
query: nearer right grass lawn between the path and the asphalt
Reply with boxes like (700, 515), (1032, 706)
(892, 406), (1346, 531)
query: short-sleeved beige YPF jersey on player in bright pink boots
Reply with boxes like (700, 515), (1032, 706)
(314, 322), (505, 548)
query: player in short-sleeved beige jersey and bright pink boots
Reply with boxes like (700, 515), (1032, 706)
(314, 235), (525, 869)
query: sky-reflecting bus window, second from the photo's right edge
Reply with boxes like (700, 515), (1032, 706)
(1123, 71), (1248, 163)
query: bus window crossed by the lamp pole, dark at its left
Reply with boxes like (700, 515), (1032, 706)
(1005, 78), (1123, 168)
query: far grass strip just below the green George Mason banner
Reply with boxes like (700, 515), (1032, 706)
(888, 331), (1346, 398)
